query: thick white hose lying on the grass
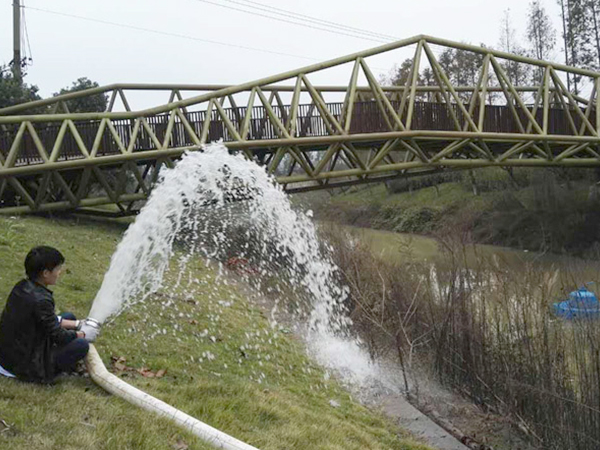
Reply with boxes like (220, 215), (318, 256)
(86, 345), (258, 450)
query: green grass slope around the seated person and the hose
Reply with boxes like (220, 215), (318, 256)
(0, 217), (428, 450)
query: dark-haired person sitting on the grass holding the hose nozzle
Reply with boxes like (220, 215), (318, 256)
(0, 246), (97, 383)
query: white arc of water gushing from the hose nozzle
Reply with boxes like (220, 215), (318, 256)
(90, 144), (392, 398)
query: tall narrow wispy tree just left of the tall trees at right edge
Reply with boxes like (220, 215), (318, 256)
(526, 0), (556, 84)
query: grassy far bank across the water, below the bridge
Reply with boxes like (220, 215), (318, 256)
(314, 169), (600, 256)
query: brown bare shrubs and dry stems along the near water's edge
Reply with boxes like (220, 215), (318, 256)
(327, 223), (600, 450)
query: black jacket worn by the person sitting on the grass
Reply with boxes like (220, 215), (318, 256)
(0, 280), (77, 383)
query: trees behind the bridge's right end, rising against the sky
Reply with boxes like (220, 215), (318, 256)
(382, 0), (600, 95)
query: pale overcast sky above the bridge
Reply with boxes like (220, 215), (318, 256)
(0, 0), (559, 106)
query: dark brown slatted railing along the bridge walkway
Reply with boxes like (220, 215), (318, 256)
(0, 101), (596, 166)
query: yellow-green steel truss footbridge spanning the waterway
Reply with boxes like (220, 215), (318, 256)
(0, 36), (600, 214)
